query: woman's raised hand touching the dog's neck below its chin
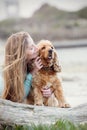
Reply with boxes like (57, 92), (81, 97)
(31, 57), (43, 74)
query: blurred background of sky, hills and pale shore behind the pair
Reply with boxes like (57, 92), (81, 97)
(0, 0), (87, 106)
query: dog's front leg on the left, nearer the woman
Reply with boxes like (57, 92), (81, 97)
(34, 88), (43, 106)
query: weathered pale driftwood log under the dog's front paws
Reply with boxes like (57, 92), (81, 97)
(0, 99), (87, 125)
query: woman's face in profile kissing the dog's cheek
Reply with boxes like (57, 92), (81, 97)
(26, 37), (38, 61)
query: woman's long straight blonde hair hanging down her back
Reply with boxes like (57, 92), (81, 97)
(2, 32), (30, 102)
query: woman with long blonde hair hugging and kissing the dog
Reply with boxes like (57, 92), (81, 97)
(2, 32), (51, 102)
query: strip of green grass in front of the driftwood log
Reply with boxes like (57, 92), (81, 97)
(0, 120), (87, 130)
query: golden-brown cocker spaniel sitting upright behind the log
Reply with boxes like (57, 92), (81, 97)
(28, 40), (70, 108)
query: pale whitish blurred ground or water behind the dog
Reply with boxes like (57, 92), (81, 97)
(0, 41), (87, 107)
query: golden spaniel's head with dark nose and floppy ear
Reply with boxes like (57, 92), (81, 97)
(37, 40), (61, 72)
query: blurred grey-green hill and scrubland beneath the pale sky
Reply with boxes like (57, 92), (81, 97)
(0, 4), (87, 41)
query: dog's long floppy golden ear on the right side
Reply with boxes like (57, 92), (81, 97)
(53, 50), (61, 72)
